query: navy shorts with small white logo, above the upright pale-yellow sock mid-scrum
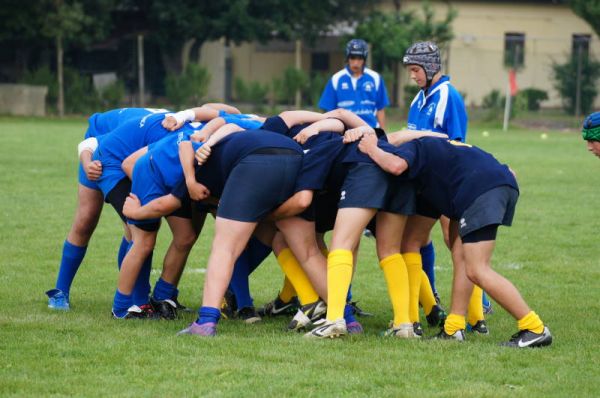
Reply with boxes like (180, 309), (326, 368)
(338, 163), (389, 210)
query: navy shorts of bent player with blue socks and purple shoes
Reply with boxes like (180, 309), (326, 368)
(217, 150), (302, 222)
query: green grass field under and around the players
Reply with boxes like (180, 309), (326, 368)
(0, 114), (600, 397)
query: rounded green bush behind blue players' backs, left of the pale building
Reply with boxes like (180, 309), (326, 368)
(165, 63), (210, 109)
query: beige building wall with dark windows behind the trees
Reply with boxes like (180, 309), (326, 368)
(203, 1), (600, 107)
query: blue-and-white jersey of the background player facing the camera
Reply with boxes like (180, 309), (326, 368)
(319, 67), (390, 127)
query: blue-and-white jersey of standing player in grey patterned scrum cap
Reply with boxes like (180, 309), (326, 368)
(408, 76), (467, 142)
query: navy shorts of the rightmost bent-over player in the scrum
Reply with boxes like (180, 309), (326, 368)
(458, 185), (519, 238)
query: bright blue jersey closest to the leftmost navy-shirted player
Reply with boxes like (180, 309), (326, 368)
(148, 130), (202, 195)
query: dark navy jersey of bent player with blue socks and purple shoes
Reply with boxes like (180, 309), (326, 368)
(195, 130), (302, 198)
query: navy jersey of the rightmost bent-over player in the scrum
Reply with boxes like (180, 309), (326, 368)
(378, 137), (519, 220)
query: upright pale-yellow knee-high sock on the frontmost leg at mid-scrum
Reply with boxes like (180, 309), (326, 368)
(327, 249), (352, 321)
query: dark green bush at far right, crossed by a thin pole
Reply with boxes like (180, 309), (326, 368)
(552, 57), (600, 114)
